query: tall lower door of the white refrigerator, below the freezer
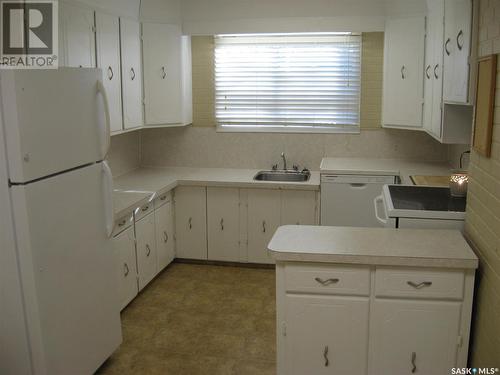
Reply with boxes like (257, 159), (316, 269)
(11, 163), (121, 374)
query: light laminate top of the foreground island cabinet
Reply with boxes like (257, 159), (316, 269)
(268, 225), (478, 269)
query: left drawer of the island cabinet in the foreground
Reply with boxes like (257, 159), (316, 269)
(285, 265), (370, 296)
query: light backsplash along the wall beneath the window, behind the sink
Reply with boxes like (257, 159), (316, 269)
(141, 127), (448, 170)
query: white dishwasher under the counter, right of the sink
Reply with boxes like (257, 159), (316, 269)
(321, 174), (398, 227)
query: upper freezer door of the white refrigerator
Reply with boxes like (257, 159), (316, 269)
(0, 68), (109, 183)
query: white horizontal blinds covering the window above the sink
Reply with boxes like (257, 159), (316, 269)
(215, 33), (361, 132)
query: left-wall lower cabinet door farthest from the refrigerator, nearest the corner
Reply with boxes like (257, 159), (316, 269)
(155, 202), (175, 272)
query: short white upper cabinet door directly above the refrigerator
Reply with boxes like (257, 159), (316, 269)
(59, 2), (96, 68)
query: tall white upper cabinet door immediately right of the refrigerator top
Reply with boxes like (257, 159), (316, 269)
(96, 13), (123, 132)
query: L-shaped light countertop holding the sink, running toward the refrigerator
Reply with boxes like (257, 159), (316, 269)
(113, 167), (320, 217)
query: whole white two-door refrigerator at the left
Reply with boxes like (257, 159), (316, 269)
(0, 68), (122, 375)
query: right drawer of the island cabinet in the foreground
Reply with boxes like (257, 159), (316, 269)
(375, 268), (464, 300)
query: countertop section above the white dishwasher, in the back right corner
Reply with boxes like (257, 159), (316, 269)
(320, 158), (452, 184)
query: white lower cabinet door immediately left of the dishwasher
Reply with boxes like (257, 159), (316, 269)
(281, 190), (317, 225)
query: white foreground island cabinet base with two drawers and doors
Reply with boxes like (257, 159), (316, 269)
(276, 261), (474, 375)
